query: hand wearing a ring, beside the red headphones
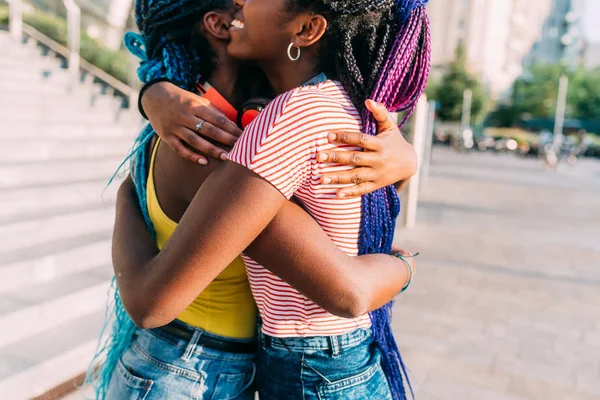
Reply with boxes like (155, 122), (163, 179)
(142, 82), (242, 165)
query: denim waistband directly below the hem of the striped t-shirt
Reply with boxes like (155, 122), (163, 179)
(259, 328), (373, 351)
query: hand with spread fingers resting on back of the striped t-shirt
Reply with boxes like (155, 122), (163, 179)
(318, 100), (417, 197)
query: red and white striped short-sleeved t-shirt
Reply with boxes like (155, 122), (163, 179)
(229, 81), (371, 337)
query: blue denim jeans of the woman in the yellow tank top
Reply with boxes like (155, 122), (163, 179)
(106, 323), (256, 400)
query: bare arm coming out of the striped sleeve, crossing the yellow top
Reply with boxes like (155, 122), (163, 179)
(113, 161), (287, 327)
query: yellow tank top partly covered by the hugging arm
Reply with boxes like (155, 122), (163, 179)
(146, 139), (258, 339)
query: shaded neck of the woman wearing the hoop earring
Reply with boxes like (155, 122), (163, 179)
(260, 55), (319, 95)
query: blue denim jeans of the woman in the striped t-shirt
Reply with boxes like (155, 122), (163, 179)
(257, 329), (392, 400)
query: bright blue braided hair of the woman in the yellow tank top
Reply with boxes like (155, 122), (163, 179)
(86, 0), (232, 400)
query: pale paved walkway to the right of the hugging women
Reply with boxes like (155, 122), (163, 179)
(394, 148), (600, 400)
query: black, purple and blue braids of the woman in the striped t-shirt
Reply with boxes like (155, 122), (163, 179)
(288, 0), (431, 400)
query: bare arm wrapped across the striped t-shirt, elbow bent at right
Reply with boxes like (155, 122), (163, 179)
(245, 201), (409, 318)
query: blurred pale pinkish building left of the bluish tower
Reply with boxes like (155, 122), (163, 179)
(428, 0), (552, 96)
